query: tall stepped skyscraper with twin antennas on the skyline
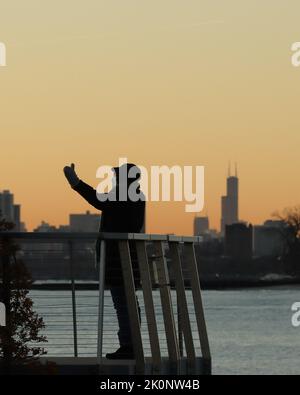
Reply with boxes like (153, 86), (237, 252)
(221, 163), (239, 234)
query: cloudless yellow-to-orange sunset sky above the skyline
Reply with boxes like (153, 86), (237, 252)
(0, 0), (300, 234)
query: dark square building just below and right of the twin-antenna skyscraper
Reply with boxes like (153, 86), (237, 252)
(224, 223), (253, 263)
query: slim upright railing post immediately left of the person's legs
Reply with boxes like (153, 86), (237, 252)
(97, 240), (106, 366)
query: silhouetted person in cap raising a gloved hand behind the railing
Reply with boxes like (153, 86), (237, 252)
(64, 163), (145, 359)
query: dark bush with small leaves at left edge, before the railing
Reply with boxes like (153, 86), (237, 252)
(0, 219), (47, 373)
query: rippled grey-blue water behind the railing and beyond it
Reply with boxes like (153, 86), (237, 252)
(31, 287), (300, 374)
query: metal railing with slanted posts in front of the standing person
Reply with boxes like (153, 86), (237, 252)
(0, 232), (211, 374)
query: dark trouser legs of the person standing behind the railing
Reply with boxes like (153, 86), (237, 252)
(106, 286), (141, 358)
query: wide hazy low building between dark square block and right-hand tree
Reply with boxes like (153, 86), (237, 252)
(254, 220), (285, 256)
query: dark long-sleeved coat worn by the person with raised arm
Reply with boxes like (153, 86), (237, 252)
(73, 180), (145, 286)
